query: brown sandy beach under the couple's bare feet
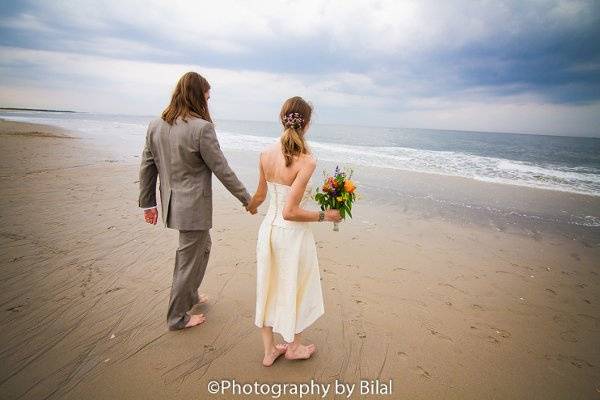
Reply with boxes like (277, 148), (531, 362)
(0, 121), (600, 399)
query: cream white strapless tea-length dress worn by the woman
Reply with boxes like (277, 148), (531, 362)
(254, 181), (325, 342)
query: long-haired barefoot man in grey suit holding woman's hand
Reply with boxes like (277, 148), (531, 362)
(139, 72), (256, 330)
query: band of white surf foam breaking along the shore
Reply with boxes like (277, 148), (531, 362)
(4, 114), (600, 198)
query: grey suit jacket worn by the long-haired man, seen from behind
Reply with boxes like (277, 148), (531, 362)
(139, 118), (250, 230)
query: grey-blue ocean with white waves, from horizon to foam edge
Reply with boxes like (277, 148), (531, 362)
(0, 111), (600, 196)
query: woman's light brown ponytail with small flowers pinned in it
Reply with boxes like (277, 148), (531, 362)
(279, 96), (312, 167)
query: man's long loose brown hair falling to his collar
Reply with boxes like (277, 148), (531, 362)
(161, 72), (212, 125)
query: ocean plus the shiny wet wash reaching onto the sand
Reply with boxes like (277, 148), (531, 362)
(0, 111), (600, 236)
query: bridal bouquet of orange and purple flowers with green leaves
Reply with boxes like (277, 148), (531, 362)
(314, 166), (357, 231)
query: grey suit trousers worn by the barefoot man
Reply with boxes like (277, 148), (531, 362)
(167, 230), (211, 330)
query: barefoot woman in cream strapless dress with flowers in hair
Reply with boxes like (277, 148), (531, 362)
(248, 97), (341, 367)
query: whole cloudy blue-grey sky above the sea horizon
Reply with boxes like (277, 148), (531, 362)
(0, 0), (600, 136)
